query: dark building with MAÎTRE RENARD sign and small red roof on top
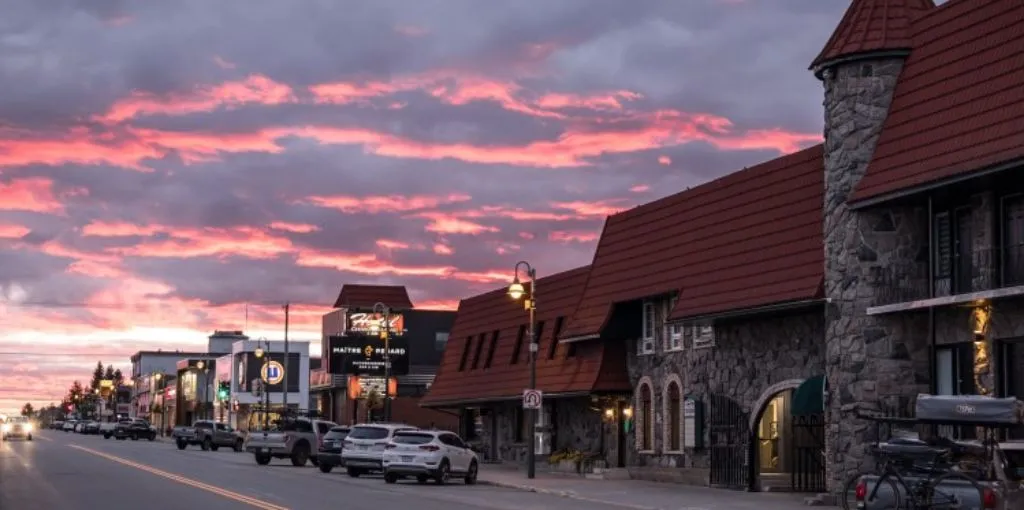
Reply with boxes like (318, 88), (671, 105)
(310, 284), (458, 428)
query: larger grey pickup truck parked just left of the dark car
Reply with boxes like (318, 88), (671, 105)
(245, 418), (338, 467)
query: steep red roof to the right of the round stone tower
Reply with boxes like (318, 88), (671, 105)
(851, 0), (1024, 201)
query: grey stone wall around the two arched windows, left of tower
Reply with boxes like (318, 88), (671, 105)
(628, 307), (824, 483)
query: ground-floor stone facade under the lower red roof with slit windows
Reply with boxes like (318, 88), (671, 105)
(476, 397), (605, 466)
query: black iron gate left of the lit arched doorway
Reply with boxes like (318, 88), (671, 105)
(708, 395), (751, 491)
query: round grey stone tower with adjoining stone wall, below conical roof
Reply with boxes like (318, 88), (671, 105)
(823, 58), (929, 492)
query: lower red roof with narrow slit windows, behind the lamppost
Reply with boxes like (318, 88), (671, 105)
(420, 266), (632, 407)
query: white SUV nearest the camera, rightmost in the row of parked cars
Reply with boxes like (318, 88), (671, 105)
(383, 430), (480, 485)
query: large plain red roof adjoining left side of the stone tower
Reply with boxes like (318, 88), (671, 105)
(562, 145), (824, 339)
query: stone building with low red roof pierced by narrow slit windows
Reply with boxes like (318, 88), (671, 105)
(421, 267), (631, 469)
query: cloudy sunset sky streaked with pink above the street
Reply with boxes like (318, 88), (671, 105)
(0, 0), (848, 412)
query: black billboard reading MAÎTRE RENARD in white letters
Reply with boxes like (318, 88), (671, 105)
(328, 335), (409, 377)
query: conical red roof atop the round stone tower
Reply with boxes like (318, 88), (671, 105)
(811, 0), (935, 73)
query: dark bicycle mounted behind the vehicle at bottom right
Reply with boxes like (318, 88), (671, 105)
(842, 445), (984, 510)
